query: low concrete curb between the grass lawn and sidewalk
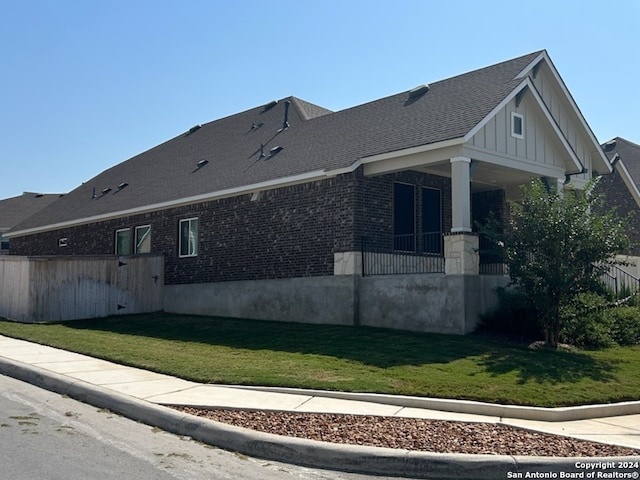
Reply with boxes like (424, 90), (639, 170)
(231, 385), (640, 422)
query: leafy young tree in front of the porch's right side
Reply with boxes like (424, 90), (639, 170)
(482, 180), (630, 348)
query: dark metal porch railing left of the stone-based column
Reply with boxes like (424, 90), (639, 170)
(362, 232), (444, 276)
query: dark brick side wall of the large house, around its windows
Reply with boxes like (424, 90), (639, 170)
(10, 169), (451, 284)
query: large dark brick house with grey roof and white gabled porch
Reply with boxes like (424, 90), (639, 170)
(8, 51), (611, 333)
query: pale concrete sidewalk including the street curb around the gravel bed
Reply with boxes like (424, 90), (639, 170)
(0, 336), (640, 479)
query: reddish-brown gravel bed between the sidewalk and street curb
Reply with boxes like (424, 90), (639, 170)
(174, 407), (640, 457)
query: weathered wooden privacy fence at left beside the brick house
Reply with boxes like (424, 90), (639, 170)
(0, 255), (164, 322)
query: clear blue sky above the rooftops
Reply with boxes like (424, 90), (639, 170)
(0, 0), (640, 199)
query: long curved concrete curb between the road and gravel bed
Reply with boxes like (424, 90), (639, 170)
(0, 358), (638, 480)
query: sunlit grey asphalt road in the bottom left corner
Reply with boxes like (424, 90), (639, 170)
(0, 375), (408, 480)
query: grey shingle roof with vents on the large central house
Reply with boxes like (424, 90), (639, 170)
(7, 52), (541, 231)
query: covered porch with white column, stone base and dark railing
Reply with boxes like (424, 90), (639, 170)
(348, 139), (572, 276)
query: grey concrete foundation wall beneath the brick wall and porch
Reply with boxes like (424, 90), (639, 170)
(164, 274), (508, 334)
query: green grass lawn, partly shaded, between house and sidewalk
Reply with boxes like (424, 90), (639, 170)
(0, 313), (640, 407)
